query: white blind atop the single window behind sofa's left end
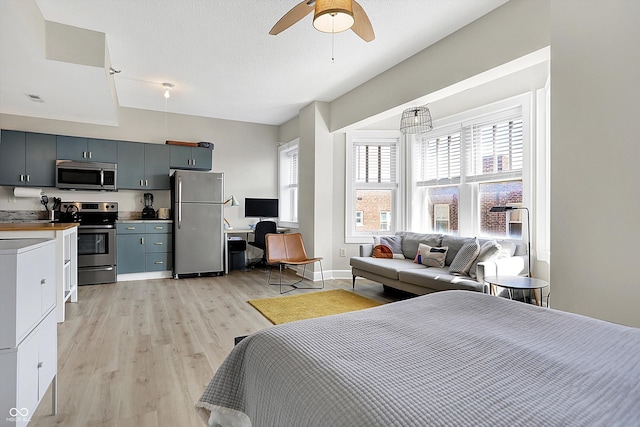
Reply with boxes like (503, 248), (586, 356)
(353, 142), (396, 184)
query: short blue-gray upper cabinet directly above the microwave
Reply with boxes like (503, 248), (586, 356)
(57, 135), (118, 163)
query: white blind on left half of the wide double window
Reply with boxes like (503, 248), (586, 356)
(415, 132), (462, 186)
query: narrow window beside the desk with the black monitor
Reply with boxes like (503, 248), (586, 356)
(278, 139), (299, 227)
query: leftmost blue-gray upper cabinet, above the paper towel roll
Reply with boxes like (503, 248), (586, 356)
(0, 130), (56, 187)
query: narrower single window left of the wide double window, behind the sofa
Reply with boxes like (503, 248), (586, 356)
(345, 131), (399, 243)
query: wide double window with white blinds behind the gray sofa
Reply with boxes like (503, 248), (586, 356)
(411, 97), (527, 239)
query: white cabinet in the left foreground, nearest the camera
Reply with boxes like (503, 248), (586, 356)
(0, 239), (58, 426)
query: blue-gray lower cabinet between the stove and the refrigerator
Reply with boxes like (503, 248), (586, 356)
(117, 221), (173, 274)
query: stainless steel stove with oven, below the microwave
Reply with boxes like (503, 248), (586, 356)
(60, 202), (118, 285)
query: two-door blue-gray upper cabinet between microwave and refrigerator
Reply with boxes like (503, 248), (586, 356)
(118, 141), (170, 190)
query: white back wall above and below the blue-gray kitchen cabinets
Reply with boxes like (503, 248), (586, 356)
(0, 108), (278, 228)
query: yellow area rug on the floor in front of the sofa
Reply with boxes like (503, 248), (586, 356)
(247, 289), (383, 325)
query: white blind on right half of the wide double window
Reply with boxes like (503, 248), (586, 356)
(466, 113), (524, 182)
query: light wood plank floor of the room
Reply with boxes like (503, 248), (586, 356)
(30, 268), (393, 427)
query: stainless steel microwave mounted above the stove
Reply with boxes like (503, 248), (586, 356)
(56, 160), (118, 191)
